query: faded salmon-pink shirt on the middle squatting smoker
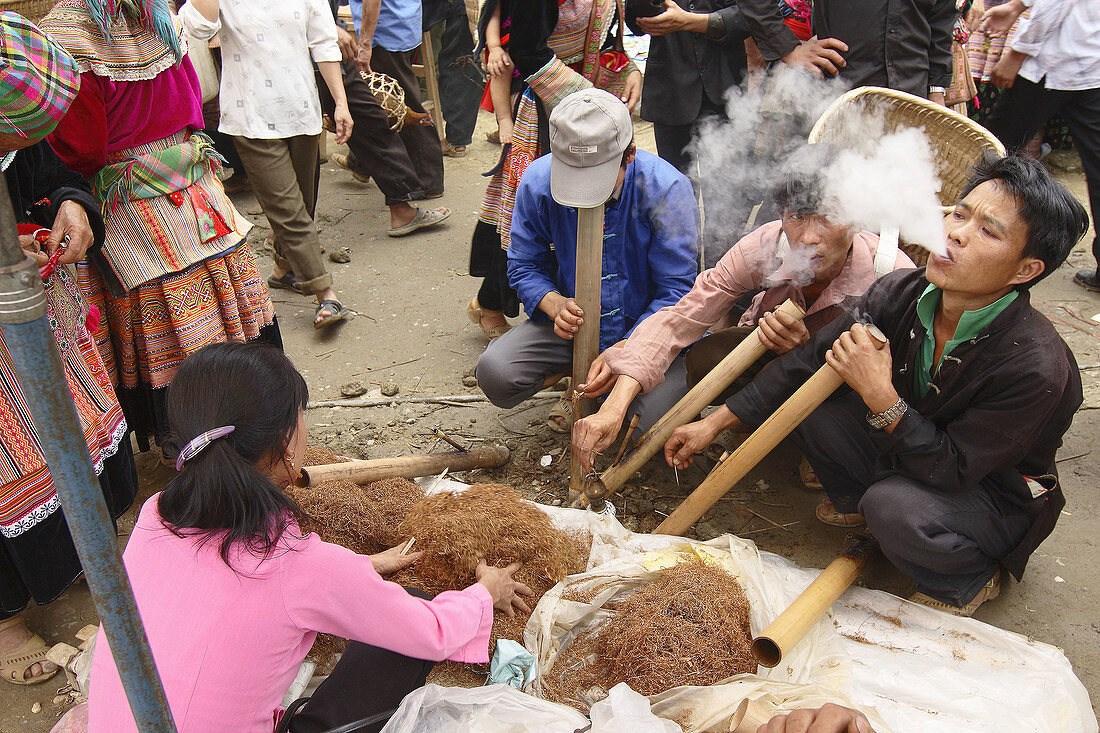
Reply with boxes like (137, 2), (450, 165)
(605, 221), (914, 392)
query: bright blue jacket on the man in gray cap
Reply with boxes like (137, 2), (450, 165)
(508, 150), (699, 351)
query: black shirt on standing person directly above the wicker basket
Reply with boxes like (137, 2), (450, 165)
(739, 0), (958, 98)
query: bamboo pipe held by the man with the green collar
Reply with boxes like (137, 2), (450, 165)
(653, 325), (887, 535)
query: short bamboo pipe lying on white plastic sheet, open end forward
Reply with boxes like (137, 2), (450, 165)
(752, 532), (878, 667)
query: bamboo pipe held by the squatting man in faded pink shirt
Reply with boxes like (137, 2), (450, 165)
(573, 300), (806, 508)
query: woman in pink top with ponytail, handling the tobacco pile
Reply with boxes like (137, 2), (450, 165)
(88, 343), (530, 733)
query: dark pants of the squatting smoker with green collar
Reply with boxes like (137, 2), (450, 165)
(792, 392), (1032, 605)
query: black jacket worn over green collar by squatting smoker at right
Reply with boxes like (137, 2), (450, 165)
(726, 269), (1082, 579)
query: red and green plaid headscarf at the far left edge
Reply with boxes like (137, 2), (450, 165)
(0, 12), (80, 138)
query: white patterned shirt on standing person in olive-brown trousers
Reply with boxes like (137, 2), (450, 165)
(179, 0), (340, 140)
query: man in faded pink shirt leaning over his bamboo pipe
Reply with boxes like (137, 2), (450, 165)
(573, 144), (913, 482)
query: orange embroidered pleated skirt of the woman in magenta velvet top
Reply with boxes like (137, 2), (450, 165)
(77, 242), (283, 450)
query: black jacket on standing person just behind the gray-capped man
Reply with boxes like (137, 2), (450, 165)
(626, 0), (749, 124)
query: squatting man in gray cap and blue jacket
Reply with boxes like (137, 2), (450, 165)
(474, 89), (699, 430)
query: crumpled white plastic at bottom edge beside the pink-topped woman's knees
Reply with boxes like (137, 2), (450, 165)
(382, 685), (589, 733)
